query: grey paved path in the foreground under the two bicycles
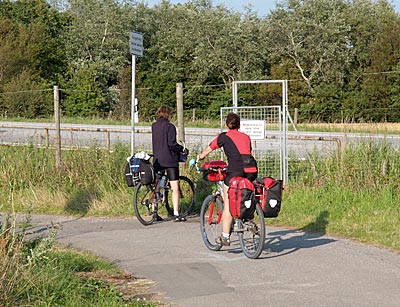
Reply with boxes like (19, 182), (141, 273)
(24, 215), (400, 307)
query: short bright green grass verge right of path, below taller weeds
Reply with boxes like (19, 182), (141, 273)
(274, 186), (400, 251)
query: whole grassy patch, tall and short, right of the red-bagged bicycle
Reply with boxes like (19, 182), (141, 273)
(270, 143), (400, 250)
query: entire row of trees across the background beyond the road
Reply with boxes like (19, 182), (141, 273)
(0, 0), (400, 122)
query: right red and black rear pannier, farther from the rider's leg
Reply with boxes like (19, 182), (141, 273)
(256, 177), (283, 218)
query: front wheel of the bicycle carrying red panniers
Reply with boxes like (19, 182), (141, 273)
(200, 195), (224, 251)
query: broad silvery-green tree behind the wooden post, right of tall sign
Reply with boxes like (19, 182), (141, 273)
(136, 1), (267, 115)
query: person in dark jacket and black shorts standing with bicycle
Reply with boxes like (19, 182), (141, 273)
(151, 106), (186, 222)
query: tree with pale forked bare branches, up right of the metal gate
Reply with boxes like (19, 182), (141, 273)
(266, 0), (351, 91)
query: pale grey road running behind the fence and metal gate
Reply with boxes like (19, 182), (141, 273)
(0, 122), (400, 159)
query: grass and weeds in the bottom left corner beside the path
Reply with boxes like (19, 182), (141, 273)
(0, 215), (159, 307)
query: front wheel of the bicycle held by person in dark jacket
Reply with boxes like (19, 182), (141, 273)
(165, 176), (196, 216)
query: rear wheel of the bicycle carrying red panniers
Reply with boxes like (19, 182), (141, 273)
(237, 204), (265, 259)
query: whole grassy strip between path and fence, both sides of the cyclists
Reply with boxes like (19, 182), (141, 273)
(0, 142), (400, 250)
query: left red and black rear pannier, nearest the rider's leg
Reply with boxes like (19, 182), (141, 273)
(228, 177), (257, 219)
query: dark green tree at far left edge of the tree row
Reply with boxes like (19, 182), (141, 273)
(0, 0), (65, 118)
